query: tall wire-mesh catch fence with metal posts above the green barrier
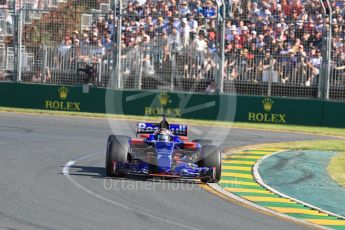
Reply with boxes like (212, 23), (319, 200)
(0, 0), (345, 100)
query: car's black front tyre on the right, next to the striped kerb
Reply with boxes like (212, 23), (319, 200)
(198, 145), (222, 183)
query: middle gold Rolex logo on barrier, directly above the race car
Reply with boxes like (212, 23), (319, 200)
(145, 93), (182, 117)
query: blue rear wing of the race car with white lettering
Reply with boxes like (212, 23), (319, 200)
(136, 122), (188, 136)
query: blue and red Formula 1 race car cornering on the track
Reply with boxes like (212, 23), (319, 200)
(105, 117), (222, 183)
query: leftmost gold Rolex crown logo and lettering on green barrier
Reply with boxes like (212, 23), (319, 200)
(45, 87), (80, 111)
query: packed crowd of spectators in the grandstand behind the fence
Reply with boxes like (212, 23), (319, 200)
(2, 0), (345, 86)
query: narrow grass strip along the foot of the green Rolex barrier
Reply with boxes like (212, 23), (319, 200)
(0, 107), (345, 137)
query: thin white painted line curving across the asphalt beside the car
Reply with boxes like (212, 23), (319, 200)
(62, 153), (199, 230)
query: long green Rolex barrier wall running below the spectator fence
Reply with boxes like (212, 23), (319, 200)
(0, 83), (345, 127)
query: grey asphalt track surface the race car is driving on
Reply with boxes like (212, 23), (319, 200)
(0, 113), (334, 230)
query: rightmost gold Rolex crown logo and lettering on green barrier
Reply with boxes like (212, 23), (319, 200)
(248, 98), (287, 124)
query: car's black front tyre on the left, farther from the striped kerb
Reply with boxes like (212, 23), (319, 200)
(105, 135), (130, 177)
